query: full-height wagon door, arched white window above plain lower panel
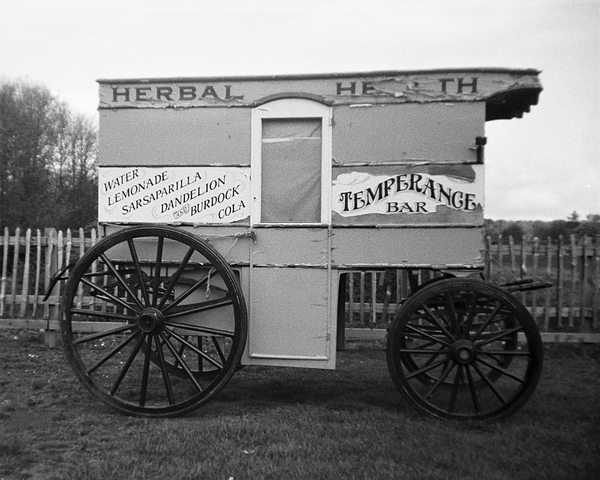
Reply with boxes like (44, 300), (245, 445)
(243, 99), (337, 368)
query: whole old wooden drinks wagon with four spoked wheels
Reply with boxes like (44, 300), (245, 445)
(55, 69), (542, 420)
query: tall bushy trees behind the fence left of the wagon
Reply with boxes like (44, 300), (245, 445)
(0, 80), (98, 229)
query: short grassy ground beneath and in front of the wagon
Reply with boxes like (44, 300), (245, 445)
(0, 330), (600, 480)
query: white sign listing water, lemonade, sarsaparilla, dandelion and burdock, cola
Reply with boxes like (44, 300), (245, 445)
(98, 167), (250, 224)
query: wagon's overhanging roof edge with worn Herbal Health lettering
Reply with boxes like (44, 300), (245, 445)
(98, 68), (542, 120)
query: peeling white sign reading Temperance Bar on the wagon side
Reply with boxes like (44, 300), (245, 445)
(333, 168), (483, 217)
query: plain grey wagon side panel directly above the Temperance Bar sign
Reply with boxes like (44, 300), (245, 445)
(333, 102), (485, 163)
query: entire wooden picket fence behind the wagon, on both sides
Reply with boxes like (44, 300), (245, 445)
(0, 229), (600, 333)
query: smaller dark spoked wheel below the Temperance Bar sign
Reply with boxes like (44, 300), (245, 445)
(387, 278), (543, 420)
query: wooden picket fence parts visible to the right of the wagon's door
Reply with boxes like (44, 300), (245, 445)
(345, 236), (600, 333)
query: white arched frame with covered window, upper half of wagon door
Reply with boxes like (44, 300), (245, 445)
(252, 99), (331, 224)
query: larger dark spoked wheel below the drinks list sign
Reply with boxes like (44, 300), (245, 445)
(61, 227), (247, 417)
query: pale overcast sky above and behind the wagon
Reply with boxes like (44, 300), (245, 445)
(0, 0), (600, 220)
